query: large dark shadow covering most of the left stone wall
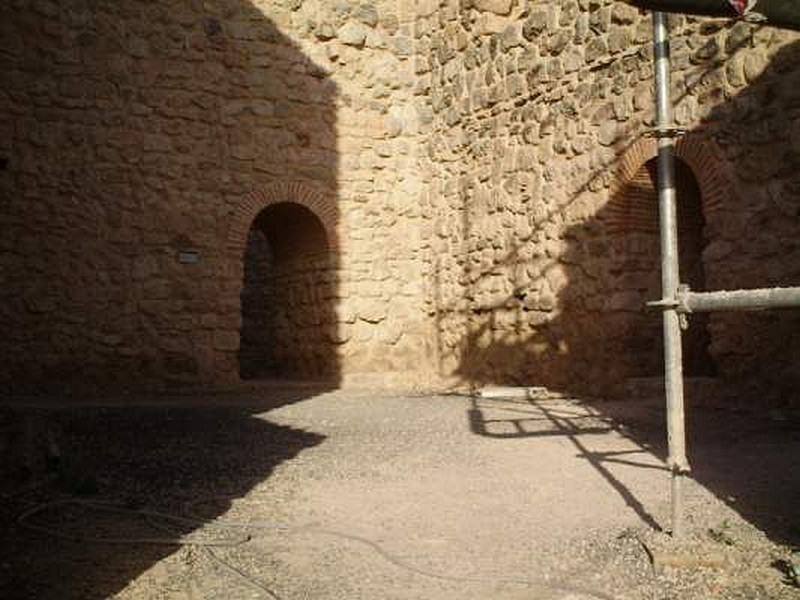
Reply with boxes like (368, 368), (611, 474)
(0, 0), (339, 394)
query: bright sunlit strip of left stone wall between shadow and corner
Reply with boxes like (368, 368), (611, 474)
(278, 0), (433, 386)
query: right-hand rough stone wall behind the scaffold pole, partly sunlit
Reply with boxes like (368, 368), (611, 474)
(416, 0), (800, 399)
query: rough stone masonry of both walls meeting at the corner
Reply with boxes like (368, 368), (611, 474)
(0, 0), (800, 402)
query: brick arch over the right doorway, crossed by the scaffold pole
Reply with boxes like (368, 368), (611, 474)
(608, 135), (736, 225)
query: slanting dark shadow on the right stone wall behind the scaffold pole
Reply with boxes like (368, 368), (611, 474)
(450, 36), (800, 404)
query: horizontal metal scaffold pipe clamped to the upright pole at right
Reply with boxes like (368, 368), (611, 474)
(677, 287), (800, 312)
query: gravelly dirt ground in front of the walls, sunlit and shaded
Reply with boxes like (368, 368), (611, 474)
(0, 387), (800, 600)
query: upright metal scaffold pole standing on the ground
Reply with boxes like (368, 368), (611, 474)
(653, 12), (689, 537)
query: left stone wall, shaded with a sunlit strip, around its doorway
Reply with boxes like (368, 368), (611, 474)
(0, 0), (432, 390)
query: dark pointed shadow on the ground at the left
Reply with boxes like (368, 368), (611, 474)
(0, 390), (324, 600)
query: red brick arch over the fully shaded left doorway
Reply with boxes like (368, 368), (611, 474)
(227, 181), (339, 254)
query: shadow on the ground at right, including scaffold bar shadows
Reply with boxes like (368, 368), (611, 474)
(468, 398), (800, 545)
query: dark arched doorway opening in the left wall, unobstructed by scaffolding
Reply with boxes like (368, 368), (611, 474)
(239, 202), (336, 380)
